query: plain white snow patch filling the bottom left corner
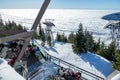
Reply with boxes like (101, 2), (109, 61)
(0, 58), (25, 80)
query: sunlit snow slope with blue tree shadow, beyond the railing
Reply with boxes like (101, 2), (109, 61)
(41, 42), (114, 78)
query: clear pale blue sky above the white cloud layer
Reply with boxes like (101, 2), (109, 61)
(0, 0), (120, 9)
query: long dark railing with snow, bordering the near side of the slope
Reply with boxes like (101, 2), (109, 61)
(34, 40), (104, 80)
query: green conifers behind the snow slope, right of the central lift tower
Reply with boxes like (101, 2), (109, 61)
(56, 23), (120, 71)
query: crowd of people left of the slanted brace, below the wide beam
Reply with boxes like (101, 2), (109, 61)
(0, 40), (23, 66)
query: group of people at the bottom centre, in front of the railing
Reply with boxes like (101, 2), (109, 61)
(58, 67), (82, 80)
